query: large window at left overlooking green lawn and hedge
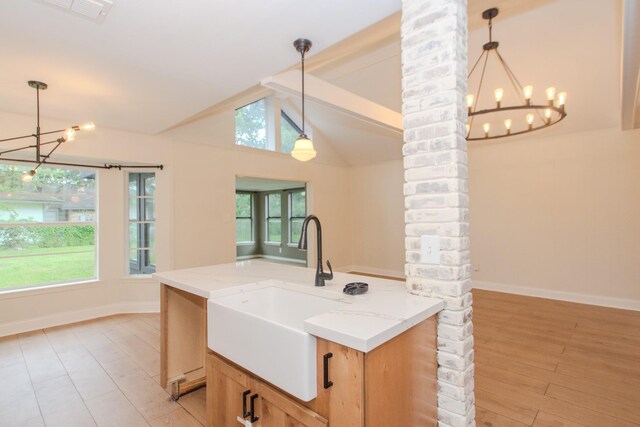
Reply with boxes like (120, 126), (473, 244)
(0, 164), (96, 291)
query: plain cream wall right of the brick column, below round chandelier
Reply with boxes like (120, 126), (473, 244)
(469, 125), (640, 309)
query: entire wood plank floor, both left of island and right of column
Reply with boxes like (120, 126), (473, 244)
(0, 290), (640, 427)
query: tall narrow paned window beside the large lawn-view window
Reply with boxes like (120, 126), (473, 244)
(129, 173), (156, 274)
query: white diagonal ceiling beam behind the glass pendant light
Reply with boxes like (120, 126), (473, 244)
(262, 70), (402, 133)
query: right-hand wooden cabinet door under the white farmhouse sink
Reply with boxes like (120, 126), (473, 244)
(253, 382), (329, 427)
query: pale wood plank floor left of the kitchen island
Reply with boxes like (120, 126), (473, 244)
(0, 314), (205, 427)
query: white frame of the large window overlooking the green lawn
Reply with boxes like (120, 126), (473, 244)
(0, 162), (100, 296)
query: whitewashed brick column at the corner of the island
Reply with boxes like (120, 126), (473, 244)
(402, 0), (475, 427)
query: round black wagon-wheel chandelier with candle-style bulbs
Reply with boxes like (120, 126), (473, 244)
(465, 8), (567, 141)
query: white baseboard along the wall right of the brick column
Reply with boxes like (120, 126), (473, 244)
(473, 280), (640, 311)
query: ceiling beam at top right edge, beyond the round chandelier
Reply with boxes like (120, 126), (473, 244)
(620, 0), (640, 130)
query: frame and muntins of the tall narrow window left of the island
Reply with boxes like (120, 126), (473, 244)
(125, 171), (158, 276)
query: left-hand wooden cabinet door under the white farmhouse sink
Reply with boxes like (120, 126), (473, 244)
(206, 353), (255, 427)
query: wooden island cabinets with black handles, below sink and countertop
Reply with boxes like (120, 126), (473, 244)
(206, 318), (437, 427)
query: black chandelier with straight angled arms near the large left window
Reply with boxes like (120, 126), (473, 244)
(0, 80), (163, 182)
